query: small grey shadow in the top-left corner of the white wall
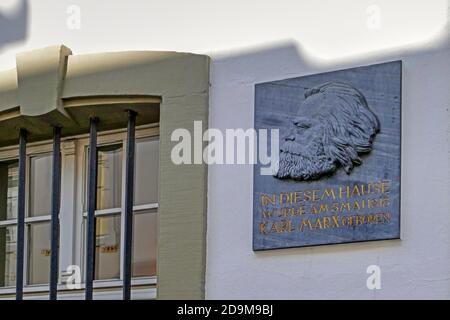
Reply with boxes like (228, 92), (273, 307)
(0, 0), (29, 52)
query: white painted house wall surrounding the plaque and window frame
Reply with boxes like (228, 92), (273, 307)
(0, 0), (450, 299)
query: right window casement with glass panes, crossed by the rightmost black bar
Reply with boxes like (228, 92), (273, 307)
(82, 131), (159, 280)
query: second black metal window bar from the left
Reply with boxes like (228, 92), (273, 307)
(50, 127), (61, 300)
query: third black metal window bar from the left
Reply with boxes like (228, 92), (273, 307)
(85, 118), (99, 300)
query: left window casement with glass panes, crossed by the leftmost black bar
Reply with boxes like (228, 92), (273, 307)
(0, 154), (52, 287)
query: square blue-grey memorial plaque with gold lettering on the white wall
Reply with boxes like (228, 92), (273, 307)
(253, 61), (402, 250)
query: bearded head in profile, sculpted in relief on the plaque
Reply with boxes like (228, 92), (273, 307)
(274, 82), (380, 181)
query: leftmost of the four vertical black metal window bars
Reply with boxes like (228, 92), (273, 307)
(16, 129), (27, 300)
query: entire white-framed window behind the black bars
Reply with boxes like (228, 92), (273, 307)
(0, 126), (159, 292)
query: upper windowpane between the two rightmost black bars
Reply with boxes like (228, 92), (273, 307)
(97, 145), (122, 210)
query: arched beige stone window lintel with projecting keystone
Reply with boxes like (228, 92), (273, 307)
(0, 45), (209, 146)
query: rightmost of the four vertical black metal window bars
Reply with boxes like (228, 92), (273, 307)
(123, 110), (136, 300)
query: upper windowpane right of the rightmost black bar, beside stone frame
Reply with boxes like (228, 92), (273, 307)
(134, 139), (159, 205)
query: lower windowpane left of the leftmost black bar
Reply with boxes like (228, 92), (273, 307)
(0, 226), (17, 287)
